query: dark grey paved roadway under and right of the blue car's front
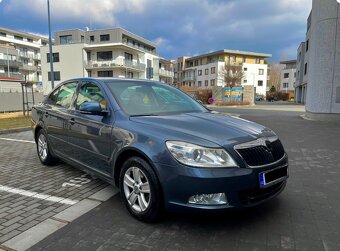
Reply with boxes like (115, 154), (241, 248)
(25, 109), (340, 251)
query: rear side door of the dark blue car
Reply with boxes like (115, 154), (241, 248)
(43, 81), (78, 157)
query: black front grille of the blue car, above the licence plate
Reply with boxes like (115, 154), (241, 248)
(236, 140), (285, 166)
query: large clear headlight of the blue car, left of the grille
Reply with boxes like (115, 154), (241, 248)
(166, 141), (237, 167)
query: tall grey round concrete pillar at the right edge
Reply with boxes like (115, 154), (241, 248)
(306, 0), (340, 113)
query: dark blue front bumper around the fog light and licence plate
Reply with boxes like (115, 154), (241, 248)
(155, 155), (288, 211)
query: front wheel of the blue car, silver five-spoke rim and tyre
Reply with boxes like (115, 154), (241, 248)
(119, 157), (163, 222)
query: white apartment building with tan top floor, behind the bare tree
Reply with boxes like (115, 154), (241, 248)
(175, 50), (271, 95)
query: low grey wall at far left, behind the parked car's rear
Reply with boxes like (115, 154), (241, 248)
(0, 92), (44, 112)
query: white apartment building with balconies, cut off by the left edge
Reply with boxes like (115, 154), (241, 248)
(0, 27), (48, 87)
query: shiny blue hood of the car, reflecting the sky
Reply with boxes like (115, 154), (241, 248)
(130, 112), (275, 146)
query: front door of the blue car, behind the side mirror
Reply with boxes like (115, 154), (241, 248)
(69, 81), (114, 175)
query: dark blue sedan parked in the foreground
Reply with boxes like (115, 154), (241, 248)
(32, 78), (288, 222)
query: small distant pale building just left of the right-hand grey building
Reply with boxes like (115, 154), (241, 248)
(280, 60), (296, 98)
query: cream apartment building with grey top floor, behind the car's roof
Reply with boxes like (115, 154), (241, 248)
(41, 28), (173, 93)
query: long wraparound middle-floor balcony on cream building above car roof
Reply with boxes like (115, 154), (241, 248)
(85, 59), (146, 71)
